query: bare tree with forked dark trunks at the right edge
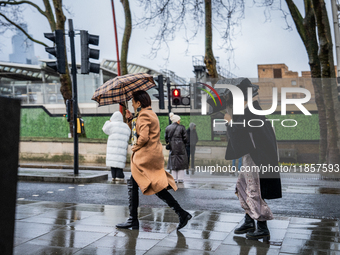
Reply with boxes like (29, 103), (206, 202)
(254, 0), (340, 164)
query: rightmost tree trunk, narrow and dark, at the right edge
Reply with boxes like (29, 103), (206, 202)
(313, 0), (339, 164)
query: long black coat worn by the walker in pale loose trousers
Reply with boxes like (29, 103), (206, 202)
(225, 101), (282, 199)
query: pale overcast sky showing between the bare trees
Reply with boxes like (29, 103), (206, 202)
(0, 0), (333, 78)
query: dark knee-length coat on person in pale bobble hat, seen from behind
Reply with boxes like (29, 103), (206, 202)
(165, 123), (188, 170)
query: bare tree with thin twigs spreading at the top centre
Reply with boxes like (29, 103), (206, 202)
(137, 0), (243, 78)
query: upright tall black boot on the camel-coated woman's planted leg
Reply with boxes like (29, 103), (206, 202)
(116, 176), (139, 229)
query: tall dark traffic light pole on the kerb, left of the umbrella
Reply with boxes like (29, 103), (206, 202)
(68, 19), (79, 175)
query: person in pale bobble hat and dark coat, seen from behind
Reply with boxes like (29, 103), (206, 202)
(165, 112), (188, 182)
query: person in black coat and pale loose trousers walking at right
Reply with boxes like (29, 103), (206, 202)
(224, 79), (282, 240)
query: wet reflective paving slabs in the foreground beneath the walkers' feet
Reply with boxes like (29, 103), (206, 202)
(14, 201), (340, 255)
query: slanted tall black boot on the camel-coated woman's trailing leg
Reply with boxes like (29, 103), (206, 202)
(156, 189), (192, 229)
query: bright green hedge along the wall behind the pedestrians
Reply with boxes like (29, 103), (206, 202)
(20, 108), (320, 141)
